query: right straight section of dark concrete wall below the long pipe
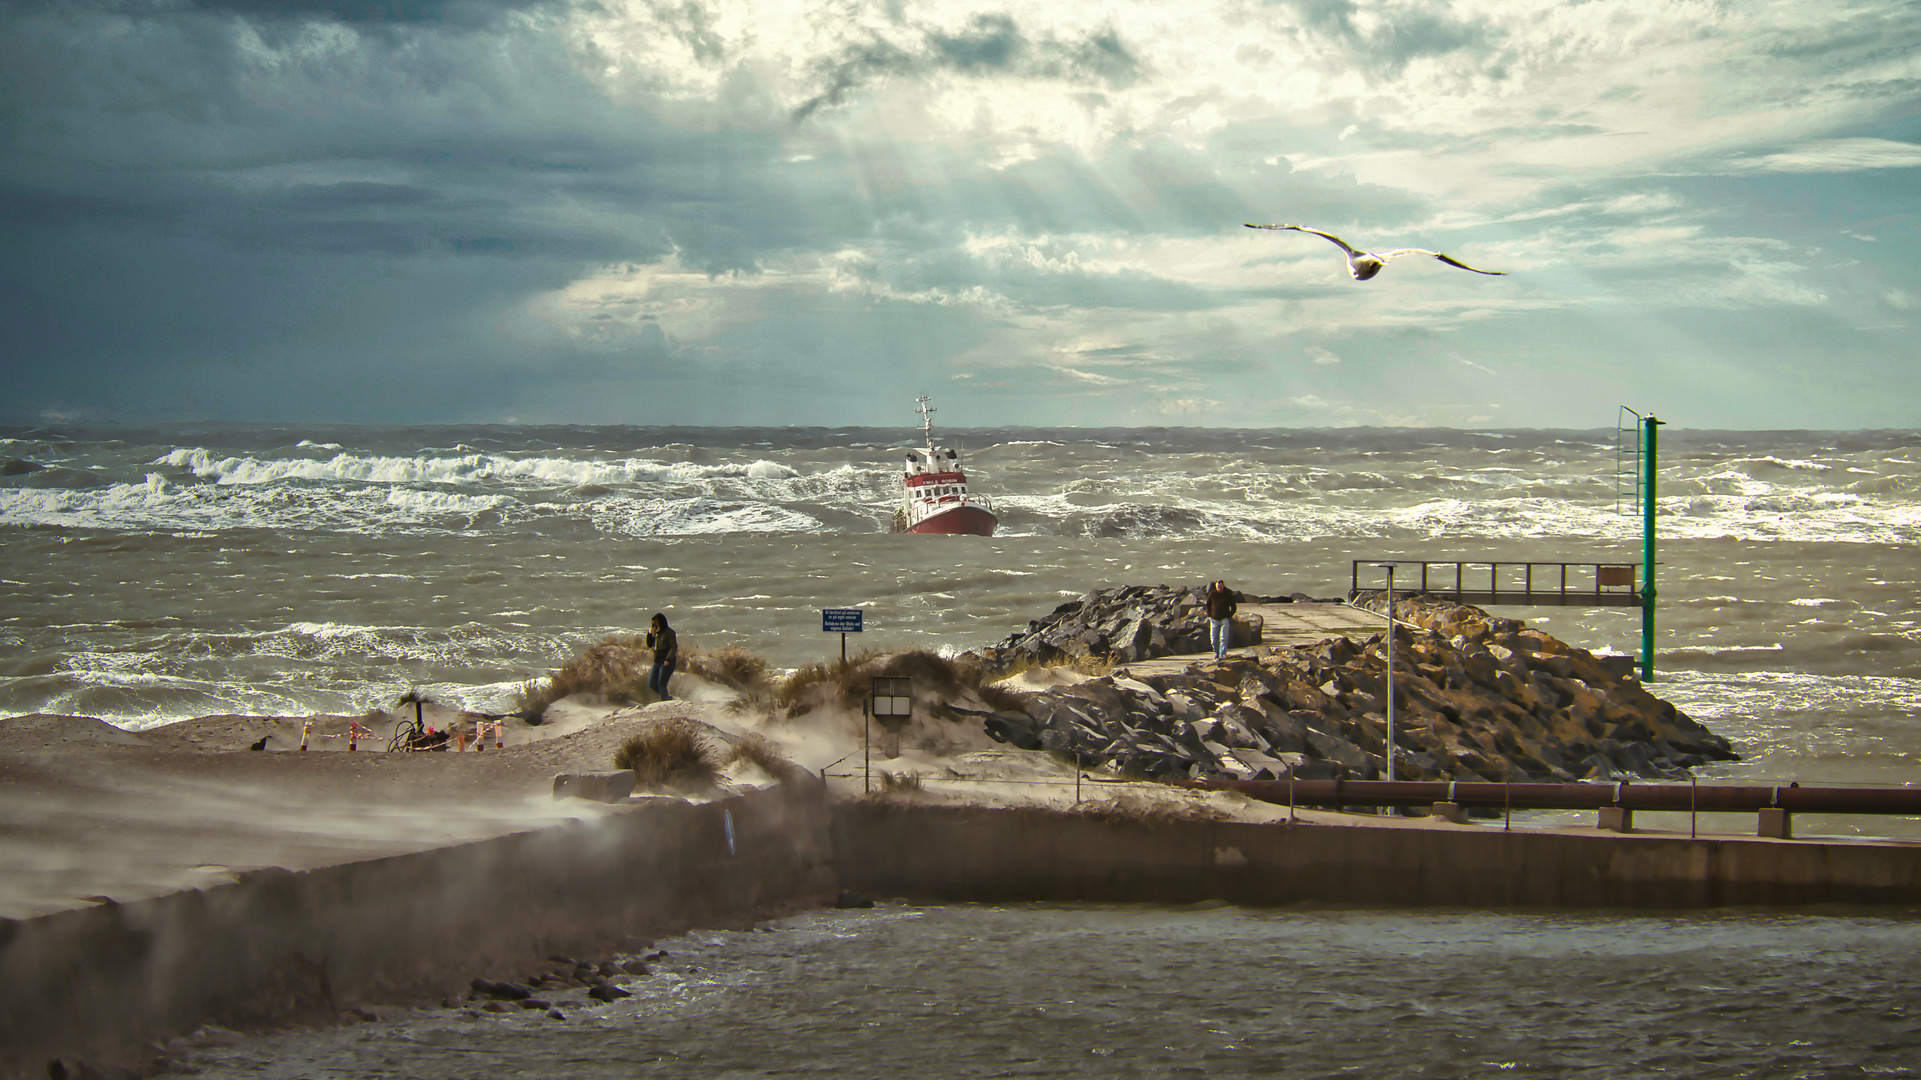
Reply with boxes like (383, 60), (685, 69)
(834, 803), (1921, 907)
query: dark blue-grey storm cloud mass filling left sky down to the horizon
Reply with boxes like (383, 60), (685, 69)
(0, 2), (833, 419)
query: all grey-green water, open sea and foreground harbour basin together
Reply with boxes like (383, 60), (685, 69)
(0, 425), (1921, 1078)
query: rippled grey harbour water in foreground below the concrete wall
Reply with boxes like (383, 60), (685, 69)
(153, 905), (1921, 1080)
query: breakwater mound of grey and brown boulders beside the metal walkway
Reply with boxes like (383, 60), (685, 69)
(985, 588), (1737, 782)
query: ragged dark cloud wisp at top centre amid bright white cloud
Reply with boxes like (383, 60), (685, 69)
(793, 13), (1141, 121)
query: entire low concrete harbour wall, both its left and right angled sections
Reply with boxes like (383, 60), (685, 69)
(11, 778), (1921, 1078)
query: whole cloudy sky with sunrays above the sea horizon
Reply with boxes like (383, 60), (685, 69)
(0, 0), (1921, 429)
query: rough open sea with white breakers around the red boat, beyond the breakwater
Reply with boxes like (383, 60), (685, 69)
(0, 420), (1921, 799)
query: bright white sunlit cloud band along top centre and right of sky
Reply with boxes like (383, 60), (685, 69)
(571, 0), (1915, 204)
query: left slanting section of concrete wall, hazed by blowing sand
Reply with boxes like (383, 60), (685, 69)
(0, 782), (836, 1076)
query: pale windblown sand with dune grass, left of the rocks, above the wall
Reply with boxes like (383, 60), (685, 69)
(0, 671), (1337, 919)
